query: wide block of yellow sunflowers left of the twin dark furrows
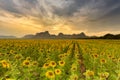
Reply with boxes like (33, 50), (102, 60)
(0, 40), (76, 80)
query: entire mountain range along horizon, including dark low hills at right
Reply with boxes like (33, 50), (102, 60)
(23, 31), (120, 39)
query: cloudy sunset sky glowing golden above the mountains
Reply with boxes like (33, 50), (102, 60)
(0, 0), (120, 37)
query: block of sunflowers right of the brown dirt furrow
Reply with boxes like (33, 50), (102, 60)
(78, 40), (120, 80)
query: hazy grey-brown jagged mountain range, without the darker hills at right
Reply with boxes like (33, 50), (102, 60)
(23, 31), (88, 39)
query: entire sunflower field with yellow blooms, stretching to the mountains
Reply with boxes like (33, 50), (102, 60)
(0, 39), (120, 80)
